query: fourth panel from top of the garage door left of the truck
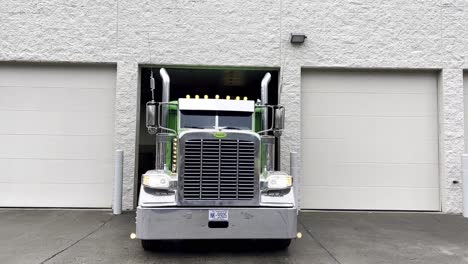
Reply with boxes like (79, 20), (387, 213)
(0, 135), (113, 160)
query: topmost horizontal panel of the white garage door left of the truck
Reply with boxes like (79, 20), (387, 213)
(0, 64), (115, 89)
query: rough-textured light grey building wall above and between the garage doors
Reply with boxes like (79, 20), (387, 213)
(0, 0), (468, 210)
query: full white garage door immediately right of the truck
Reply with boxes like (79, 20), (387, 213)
(301, 70), (440, 210)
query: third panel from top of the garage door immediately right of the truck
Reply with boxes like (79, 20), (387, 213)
(302, 116), (438, 140)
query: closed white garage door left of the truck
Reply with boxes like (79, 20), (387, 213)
(0, 64), (115, 207)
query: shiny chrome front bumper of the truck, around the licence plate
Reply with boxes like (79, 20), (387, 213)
(136, 206), (297, 240)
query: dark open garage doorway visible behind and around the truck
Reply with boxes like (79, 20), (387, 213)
(135, 67), (279, 199)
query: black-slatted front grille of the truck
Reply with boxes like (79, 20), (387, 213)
(182, 139), (256, 201)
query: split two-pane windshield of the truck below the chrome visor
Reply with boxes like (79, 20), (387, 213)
(180, 110), (252, 130)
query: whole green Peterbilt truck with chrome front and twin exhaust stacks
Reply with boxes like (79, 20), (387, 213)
(136, 68), (297, 250)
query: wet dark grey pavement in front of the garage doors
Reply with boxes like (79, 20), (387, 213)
(0, 209), (468, 264)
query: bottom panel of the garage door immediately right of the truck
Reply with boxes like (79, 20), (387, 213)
(300, 187), (440, 211)
